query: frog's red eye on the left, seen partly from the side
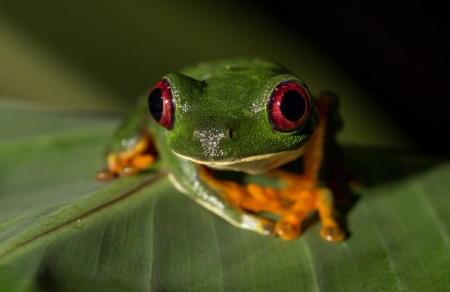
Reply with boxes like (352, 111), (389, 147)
(148, 79), (175, 130)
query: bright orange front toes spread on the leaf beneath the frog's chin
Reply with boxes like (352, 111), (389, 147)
(200, 166), (345, 242)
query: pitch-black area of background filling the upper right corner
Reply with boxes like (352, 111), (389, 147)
(253, 0), (450, 156)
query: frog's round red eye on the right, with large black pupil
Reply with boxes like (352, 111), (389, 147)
(267, 80), (310, 132)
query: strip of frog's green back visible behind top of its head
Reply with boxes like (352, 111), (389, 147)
(180, 58), (289, 81)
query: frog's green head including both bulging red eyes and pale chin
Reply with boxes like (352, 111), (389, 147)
(148, 59), (317, 173)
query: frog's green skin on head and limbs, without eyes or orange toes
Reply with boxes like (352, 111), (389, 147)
(112, 59), (318, 234)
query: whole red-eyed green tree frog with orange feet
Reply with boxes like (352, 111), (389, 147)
(97, 58), (345, 241)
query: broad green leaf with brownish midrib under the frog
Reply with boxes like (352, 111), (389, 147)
(0, 106), (450, 291)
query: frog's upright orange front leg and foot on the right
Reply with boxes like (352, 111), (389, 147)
(272, 92), (345, 242)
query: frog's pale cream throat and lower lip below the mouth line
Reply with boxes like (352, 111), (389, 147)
(173, 145), (306, 174)
